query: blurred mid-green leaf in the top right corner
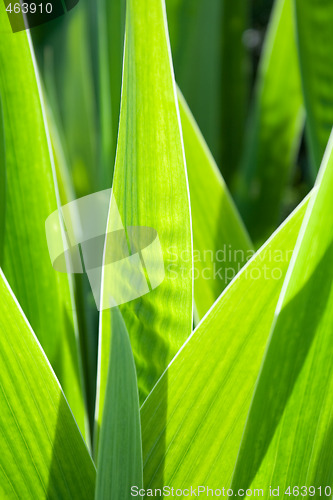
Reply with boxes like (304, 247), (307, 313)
(294, 0), (333, 177)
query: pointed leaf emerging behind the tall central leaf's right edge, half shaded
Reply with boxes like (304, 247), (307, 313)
(178, 91), (253, 319)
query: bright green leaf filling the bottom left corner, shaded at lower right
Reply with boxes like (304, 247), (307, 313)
(0, 270), (95, 500)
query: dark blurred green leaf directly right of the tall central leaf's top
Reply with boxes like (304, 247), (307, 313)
(167, 0), (248, 182)
